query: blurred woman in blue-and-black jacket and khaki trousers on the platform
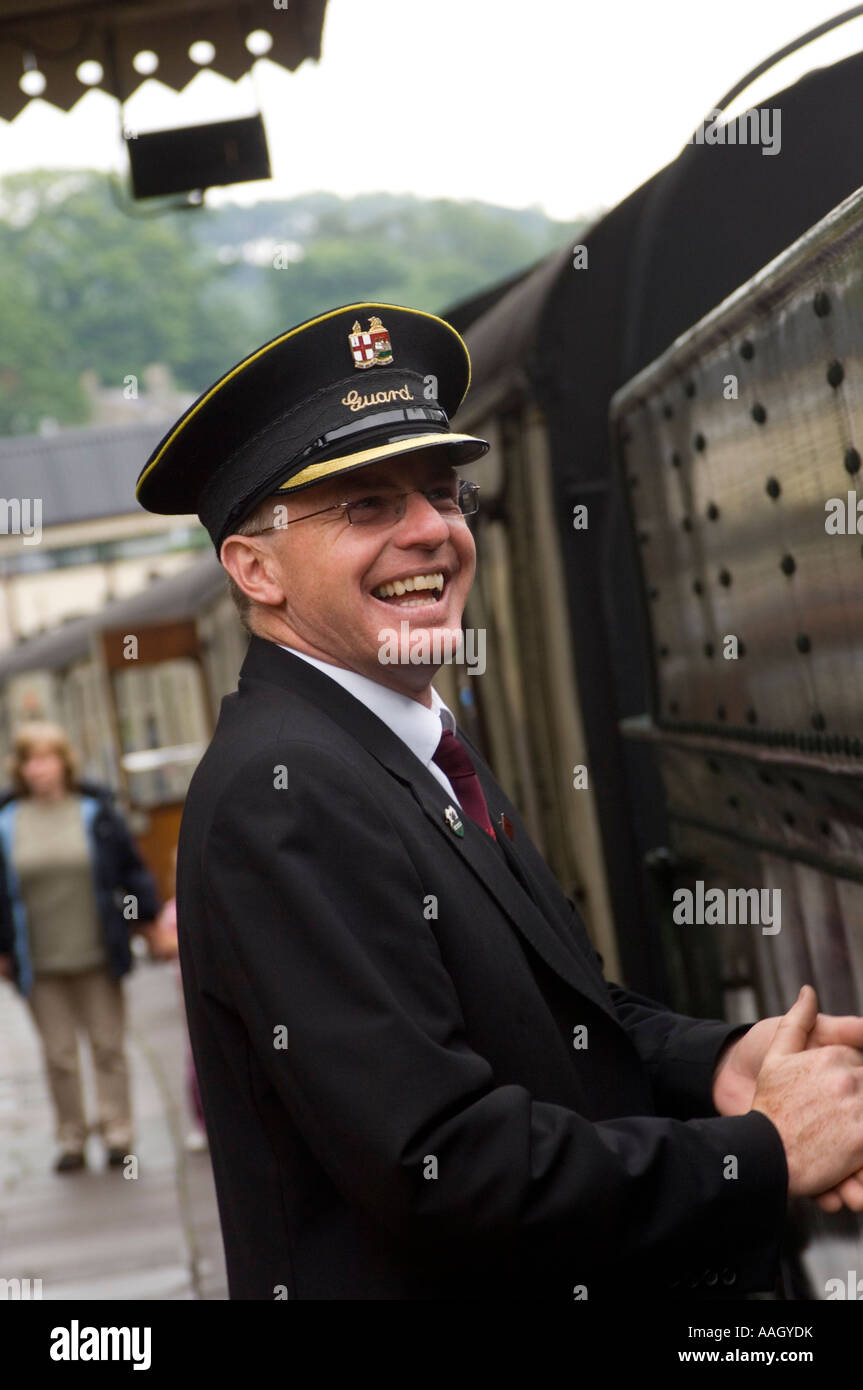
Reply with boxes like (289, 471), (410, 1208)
(0, 721), (158, 1173)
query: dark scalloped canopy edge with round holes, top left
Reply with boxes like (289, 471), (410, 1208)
(0, 0), (327, 121)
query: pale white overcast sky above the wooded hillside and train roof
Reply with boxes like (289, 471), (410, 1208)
(0, 0), (863, 217)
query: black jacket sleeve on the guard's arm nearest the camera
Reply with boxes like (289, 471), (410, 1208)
(197, 741), (787, 1269)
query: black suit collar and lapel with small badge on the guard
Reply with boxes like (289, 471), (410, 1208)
(239, 637), (620, 1023)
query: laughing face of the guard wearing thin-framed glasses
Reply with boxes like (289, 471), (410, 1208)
(221, 441), (475, 708)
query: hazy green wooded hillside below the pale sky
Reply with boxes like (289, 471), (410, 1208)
(0, 170), (575, 434)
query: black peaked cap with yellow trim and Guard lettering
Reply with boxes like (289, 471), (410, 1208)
(135, 303), (488, 552)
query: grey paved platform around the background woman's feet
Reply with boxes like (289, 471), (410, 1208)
(0, 960), (228, 1301)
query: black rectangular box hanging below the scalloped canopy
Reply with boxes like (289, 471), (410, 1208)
(126, 115), (271, 197)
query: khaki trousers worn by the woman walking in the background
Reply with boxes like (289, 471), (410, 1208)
(28, 966), (132, 1152)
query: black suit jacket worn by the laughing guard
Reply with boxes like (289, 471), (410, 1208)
(178, 637), (787, 1300)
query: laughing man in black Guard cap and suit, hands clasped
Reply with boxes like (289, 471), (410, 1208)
(138, 303), (863, 1301)
